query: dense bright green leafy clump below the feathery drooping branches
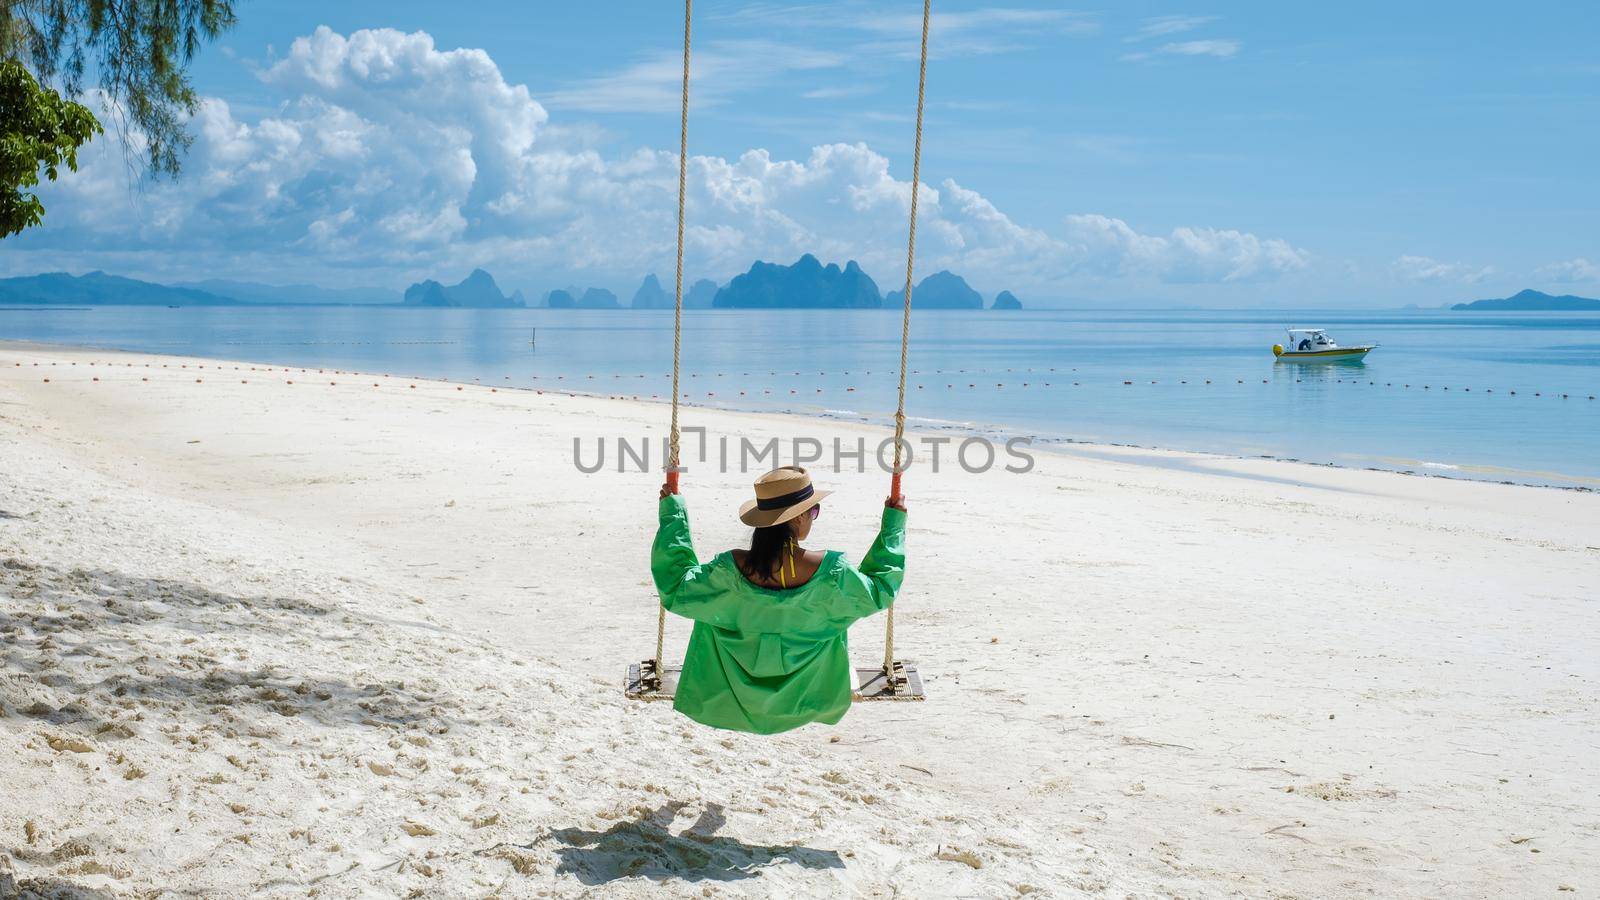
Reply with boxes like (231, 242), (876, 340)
(0, 59), (101, 237)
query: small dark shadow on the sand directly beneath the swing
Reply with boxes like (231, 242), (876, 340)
(528, 801), (845, 886)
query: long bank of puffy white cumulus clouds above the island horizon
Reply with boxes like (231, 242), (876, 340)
(6, 29), (1307, 290)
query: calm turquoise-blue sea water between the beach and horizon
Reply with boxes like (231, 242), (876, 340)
(0, 307), (1600, 487)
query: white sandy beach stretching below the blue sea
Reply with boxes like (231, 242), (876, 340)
(0, 344), (1600, 897)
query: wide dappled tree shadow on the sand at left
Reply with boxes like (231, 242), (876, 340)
(0, 557), (486, 738)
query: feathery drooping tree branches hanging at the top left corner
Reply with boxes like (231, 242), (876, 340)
(0, 0), (235, 176)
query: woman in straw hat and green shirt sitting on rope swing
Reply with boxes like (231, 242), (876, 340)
(650, 466), (906, 735)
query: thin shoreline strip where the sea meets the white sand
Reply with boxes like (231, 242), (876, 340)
(0, 340), (1600, 493)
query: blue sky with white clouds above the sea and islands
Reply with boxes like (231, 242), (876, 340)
(0, 0), (1600, 306)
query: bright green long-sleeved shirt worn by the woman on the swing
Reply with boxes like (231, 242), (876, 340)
(650, 495), (906, 735)
